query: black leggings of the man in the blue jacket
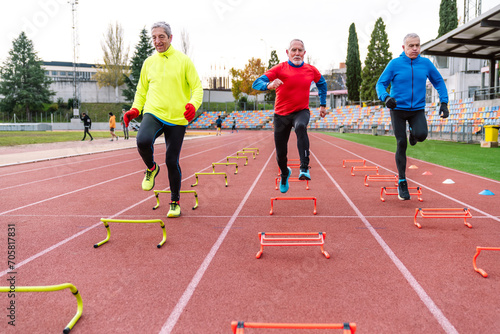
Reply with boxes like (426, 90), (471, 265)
(391, 109), (428, 179)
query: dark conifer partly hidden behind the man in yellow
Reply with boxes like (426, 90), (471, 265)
(122, 28), (155, 102)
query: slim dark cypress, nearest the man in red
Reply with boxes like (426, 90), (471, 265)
(345, 23), (361, 101)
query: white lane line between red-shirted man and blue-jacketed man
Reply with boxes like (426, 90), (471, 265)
(311, 152), (458, 334)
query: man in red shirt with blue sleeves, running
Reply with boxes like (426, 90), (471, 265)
(252, 39), (327, 193)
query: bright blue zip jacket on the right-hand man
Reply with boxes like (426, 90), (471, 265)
(376, 52), (448, 111)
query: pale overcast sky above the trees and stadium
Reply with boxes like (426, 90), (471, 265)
(0, 0), (500, 76)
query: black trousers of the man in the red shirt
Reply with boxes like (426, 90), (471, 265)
(274, 109), (310, 176)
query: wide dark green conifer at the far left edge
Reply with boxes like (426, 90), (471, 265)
(0, 31), (55, 121)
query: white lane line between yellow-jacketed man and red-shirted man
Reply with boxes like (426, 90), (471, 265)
(160, 150), (274, 334)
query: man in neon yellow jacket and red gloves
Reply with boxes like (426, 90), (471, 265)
(123, 22), (203, 218)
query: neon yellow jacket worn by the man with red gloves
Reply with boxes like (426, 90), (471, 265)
(132, 45), (203, 125)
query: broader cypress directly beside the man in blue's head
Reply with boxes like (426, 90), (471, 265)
(360, 17), (392, 101)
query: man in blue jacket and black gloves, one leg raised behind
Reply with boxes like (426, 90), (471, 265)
(376, 34), (449, 200)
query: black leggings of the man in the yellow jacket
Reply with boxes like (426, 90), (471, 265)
(137, 114), (186, 201)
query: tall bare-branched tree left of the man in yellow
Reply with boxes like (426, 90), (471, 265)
(95, 22), (130, 102)
